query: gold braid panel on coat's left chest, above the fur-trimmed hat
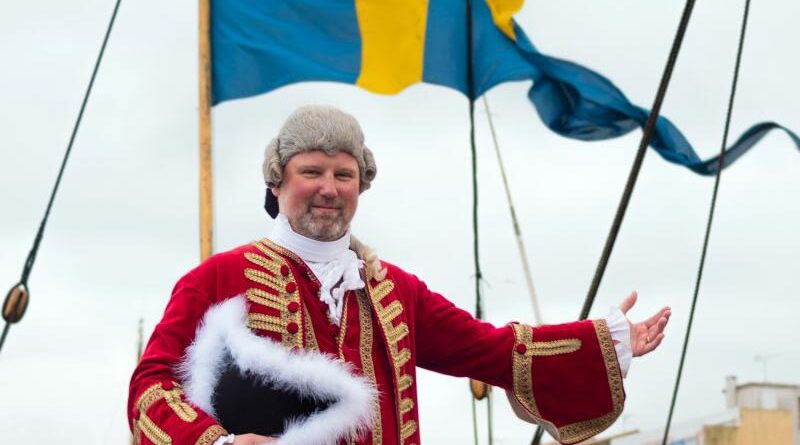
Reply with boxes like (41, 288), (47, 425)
(244, 239), (306, 349)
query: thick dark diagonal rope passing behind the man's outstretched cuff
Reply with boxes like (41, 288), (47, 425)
(531, 0), (694, 445)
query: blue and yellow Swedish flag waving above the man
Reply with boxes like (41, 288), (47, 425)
(211, 0), (800, 175)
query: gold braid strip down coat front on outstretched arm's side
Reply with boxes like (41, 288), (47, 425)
(366, 270), (417, 443)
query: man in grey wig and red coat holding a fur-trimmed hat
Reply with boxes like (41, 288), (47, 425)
(128, 106), (670, 445)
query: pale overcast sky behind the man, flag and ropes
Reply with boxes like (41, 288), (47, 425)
(0, 0), (800, 445)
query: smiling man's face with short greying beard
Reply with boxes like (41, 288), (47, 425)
(272, 150), (360, 241)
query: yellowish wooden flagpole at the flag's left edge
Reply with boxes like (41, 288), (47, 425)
(198, 0), (214, 261)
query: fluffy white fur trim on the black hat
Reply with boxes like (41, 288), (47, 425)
(178, 296), (377, 445)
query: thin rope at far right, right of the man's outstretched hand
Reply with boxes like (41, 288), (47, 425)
(661, 0), (750, 445)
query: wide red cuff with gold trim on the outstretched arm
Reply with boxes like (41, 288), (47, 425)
(509, 320), (625, 444)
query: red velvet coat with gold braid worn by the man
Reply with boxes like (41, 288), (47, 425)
(128, 240), (625, 445)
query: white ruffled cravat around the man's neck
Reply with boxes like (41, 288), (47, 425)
(269, 213), (364, 325)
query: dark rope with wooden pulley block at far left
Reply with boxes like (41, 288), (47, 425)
(0, 0), (121, 351)
